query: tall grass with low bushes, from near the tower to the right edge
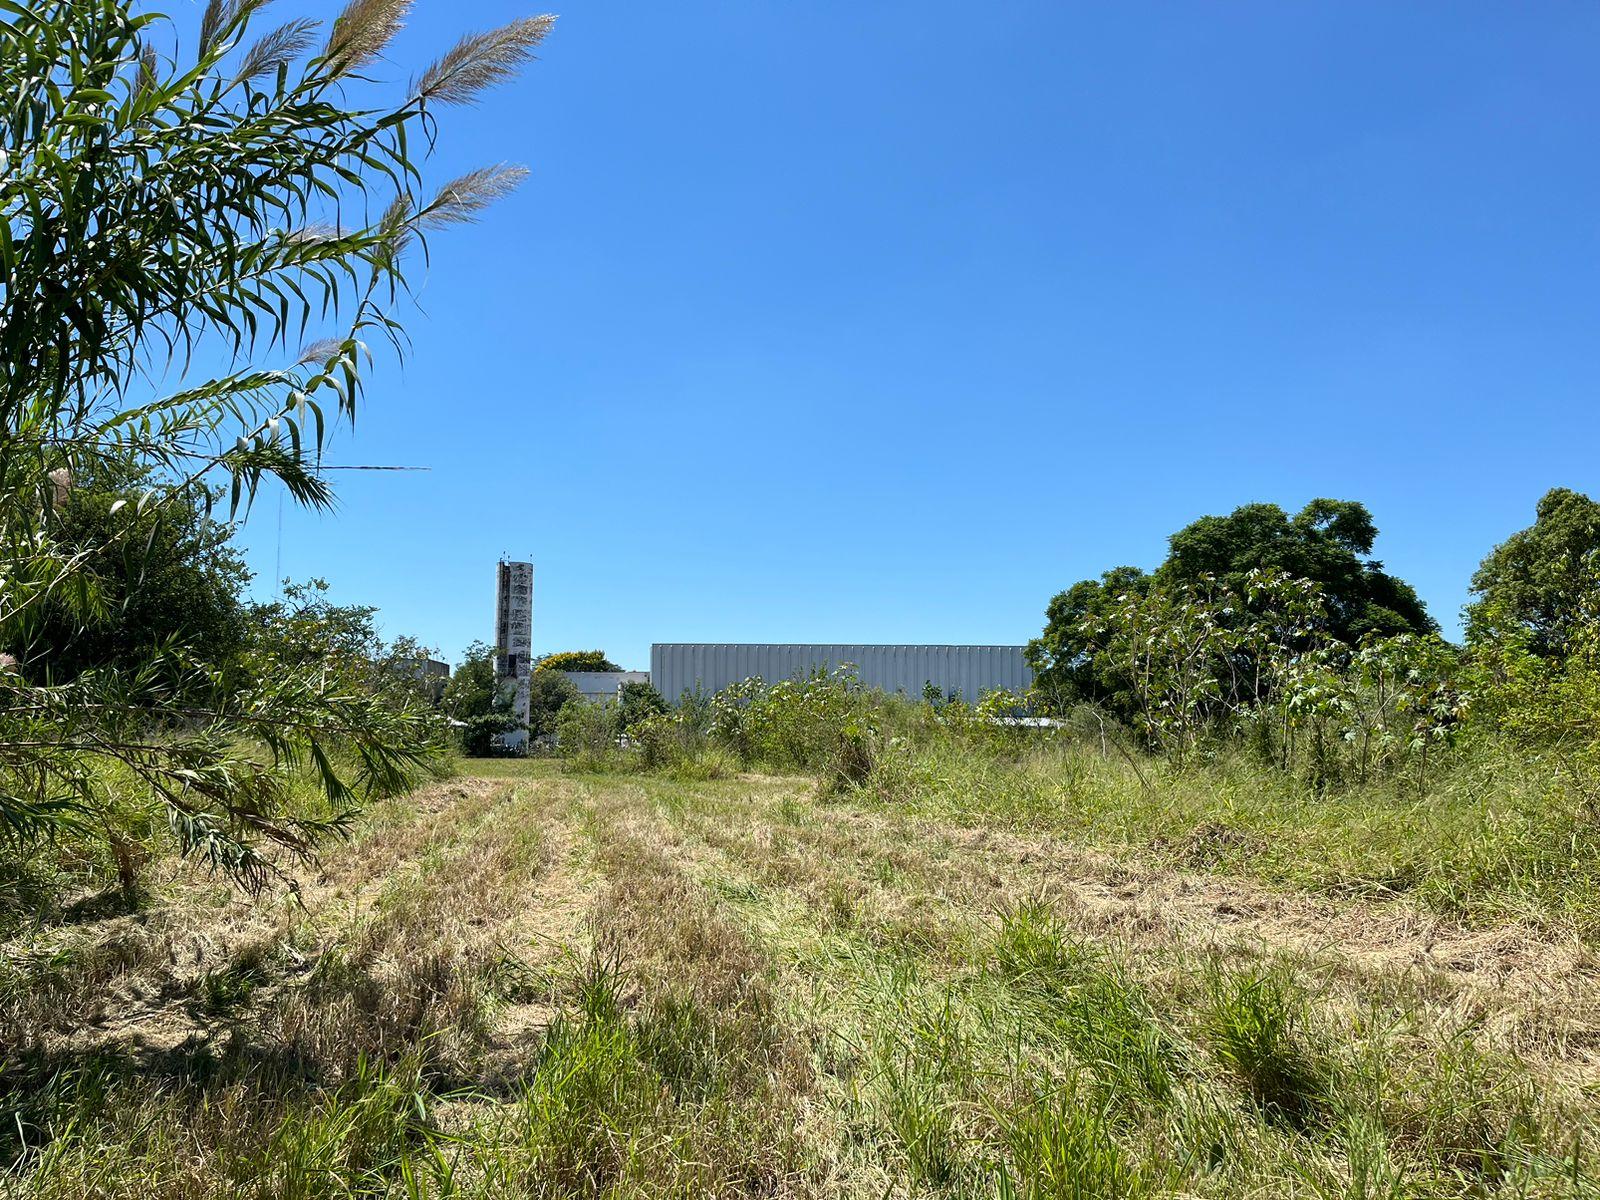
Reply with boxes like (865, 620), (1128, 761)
(573, 675), (1600, 938)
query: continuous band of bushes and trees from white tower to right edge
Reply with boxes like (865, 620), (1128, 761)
(542, 490), (1600, 819)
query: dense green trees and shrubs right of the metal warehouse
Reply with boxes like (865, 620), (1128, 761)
(1029, 488), (1600, 800)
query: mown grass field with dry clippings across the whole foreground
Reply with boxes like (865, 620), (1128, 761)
(0, 763), (1600, 1197)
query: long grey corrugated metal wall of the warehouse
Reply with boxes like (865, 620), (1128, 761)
(650, 642), (1034, 702)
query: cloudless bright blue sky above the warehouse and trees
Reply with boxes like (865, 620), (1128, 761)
(228, 0), (1600, 667)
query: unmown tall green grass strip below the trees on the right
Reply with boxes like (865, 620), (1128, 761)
(864, 733), (1600, 936)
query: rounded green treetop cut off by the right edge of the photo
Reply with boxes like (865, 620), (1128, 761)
(1467, 488), (1600, 658)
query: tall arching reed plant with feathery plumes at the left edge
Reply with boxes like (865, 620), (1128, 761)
(0, 0), (550, 886)
